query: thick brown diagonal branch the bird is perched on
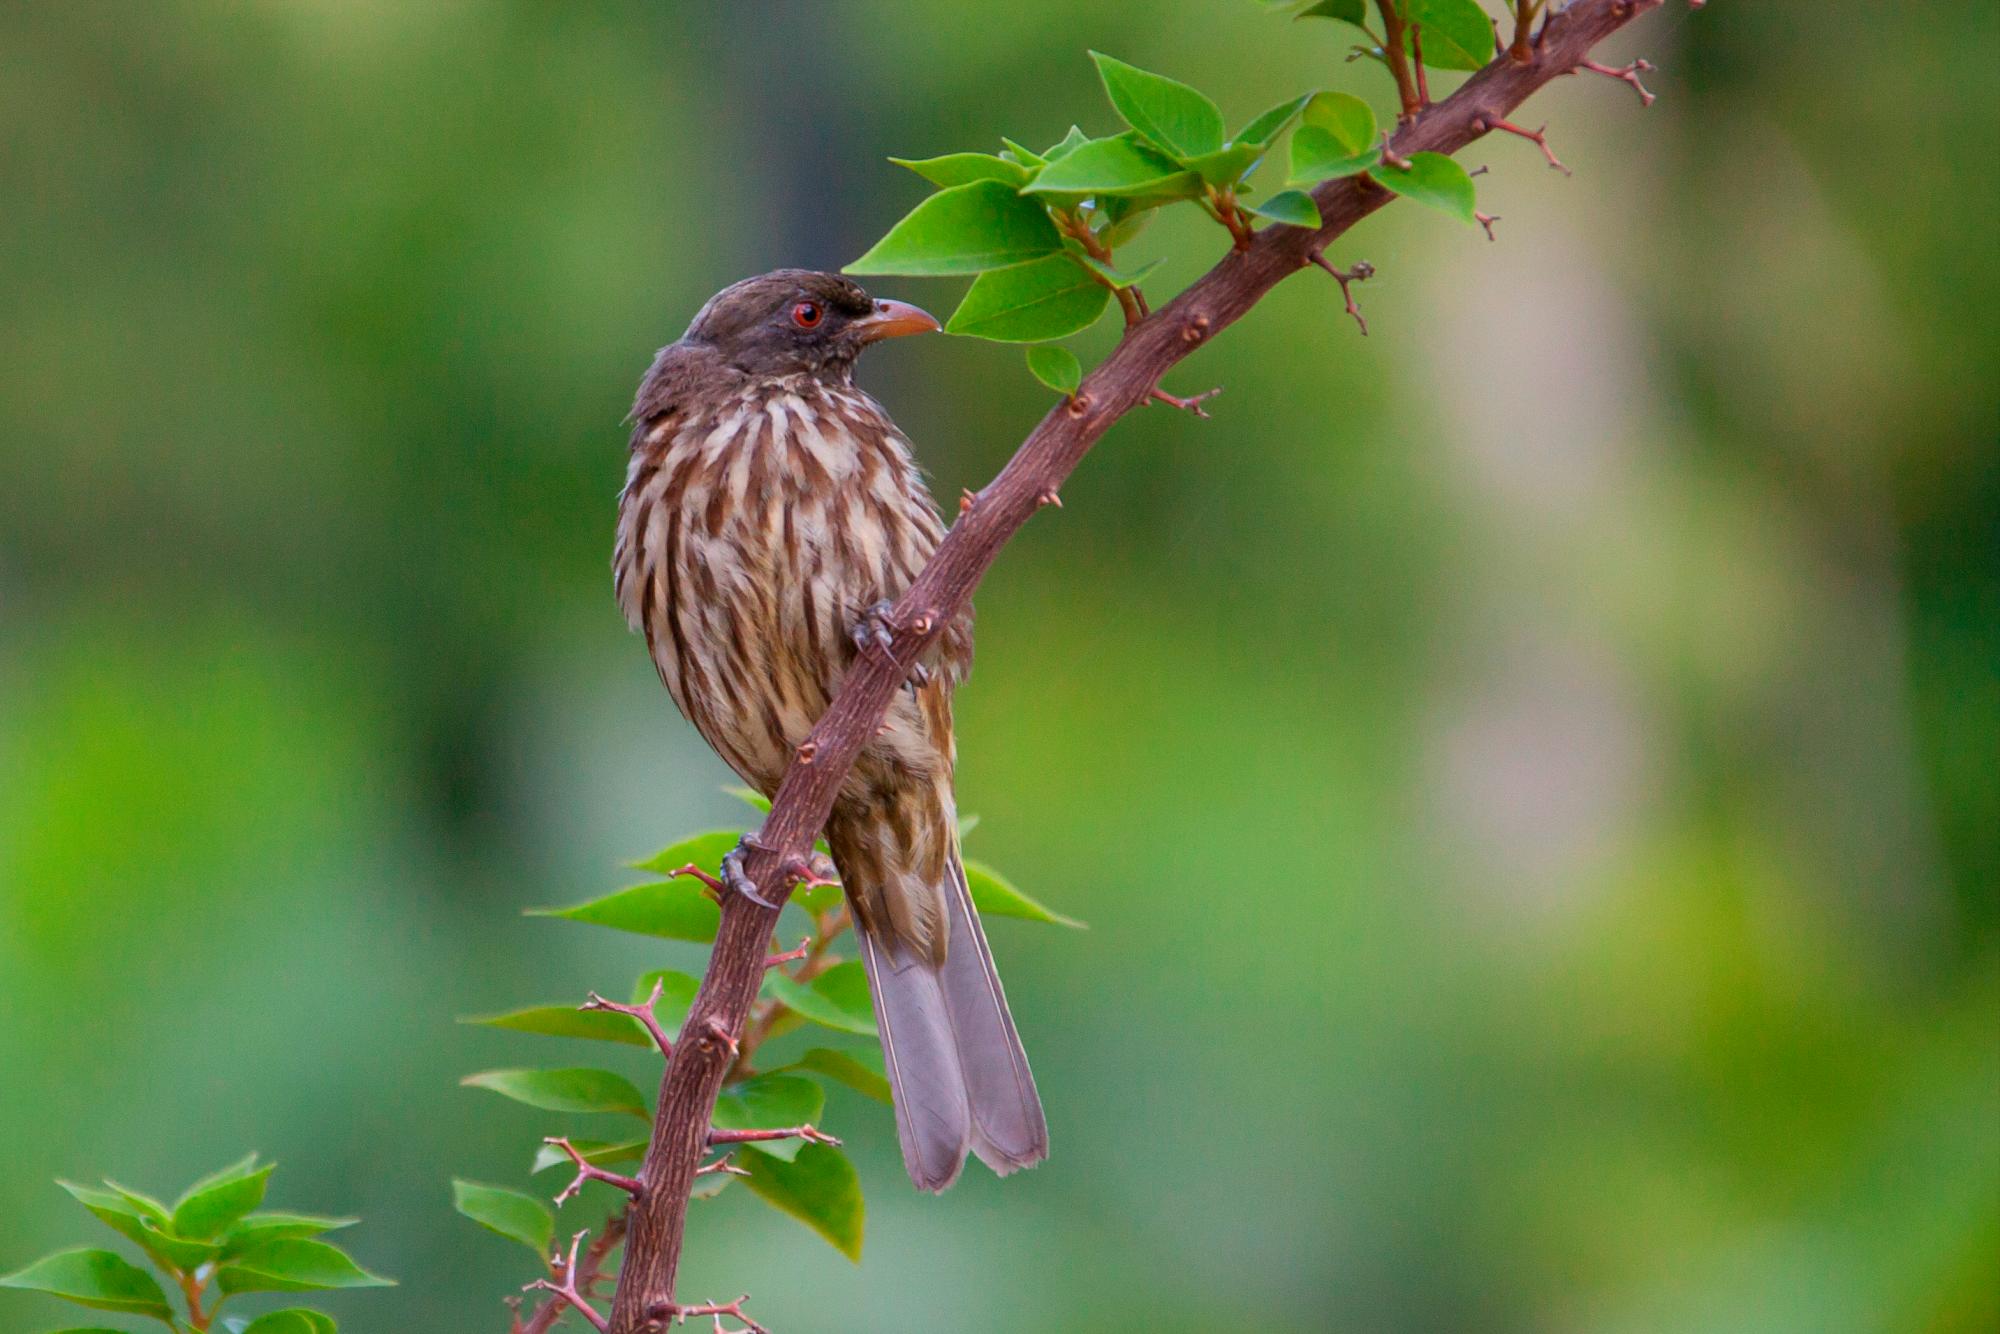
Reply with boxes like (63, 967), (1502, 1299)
(612, 0), (1662, 1334)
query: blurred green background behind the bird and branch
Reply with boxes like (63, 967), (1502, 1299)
(0, 0), (2000, 1332)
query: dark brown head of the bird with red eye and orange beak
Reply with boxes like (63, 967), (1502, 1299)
(682, 268), (938, 380)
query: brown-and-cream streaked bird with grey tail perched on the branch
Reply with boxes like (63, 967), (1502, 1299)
(612, 268), (1048, 1192)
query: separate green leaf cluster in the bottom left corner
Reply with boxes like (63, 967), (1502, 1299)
(0, 1154), (392, 1334)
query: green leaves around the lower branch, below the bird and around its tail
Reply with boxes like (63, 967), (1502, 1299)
(452, 790), (1082, 1264)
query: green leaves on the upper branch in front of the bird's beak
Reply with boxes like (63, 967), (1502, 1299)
(846, 40), (1492, 386)
